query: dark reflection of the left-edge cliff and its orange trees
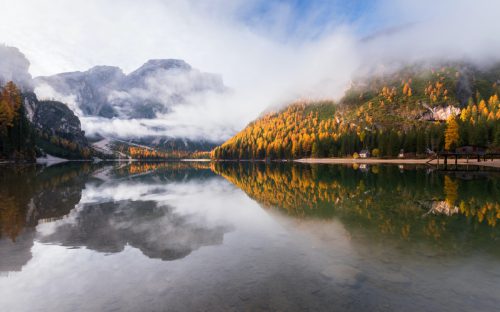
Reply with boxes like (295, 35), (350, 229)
(0, 164), (92, 271)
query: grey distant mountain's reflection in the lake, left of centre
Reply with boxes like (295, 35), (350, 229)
(39, 201), (228, 260)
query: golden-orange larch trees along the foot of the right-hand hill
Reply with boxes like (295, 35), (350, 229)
(211, 95), (500, 159)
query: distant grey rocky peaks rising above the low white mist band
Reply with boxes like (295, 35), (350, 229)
(35, 59), (226, 119)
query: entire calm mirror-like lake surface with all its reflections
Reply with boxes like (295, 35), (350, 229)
(0, 162), (500, 312)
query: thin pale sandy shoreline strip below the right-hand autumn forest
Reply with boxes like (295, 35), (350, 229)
(294, 158), (500, 168)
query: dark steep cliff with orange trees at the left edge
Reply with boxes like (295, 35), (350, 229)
(0, 45), (91, 161)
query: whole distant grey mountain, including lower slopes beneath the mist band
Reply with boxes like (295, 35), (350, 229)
(34, 59), (227, 157)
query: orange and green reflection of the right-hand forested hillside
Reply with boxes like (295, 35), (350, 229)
(213, 163), (500, 249)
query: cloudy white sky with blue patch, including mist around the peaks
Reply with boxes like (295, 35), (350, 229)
(0, 0), (500, 140)
